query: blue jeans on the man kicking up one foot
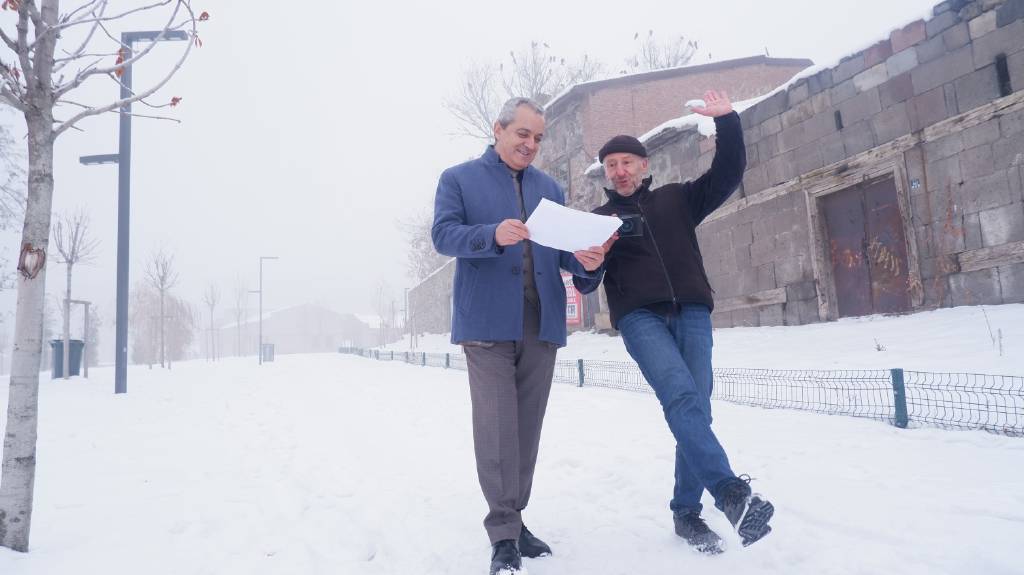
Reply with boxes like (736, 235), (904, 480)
(618, 305), (735, 514)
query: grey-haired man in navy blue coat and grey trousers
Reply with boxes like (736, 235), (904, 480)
(431, 98), (604, 574)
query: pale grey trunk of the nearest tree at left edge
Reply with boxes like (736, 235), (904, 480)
(0, 111), (53, 551)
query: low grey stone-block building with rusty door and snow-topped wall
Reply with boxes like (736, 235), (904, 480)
(578, 0), (1024, 326)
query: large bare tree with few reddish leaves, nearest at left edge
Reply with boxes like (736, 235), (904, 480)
(0, 0), (203, 551)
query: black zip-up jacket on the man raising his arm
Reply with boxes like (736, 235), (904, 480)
(573, 113), (746, 326)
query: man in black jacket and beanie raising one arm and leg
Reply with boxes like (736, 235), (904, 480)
(573, 91), (774, 554)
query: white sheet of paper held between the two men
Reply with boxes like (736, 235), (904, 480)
(526, 198), (623, 252)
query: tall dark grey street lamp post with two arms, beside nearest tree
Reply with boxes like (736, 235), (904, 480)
(79, 30), (188, 393)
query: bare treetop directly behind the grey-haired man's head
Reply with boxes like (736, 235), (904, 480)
(444, 42), (604, 140)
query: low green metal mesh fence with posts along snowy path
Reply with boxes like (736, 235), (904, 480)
(339, 348), (1024, 436)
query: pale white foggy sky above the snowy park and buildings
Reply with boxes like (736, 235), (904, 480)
(0, 0), (937, 347)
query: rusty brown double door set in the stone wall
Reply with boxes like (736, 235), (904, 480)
(821, 179), (910, 317)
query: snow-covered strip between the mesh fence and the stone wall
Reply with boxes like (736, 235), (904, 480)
(388, 304), (1024, 375)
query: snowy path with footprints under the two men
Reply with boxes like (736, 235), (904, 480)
(0, 355), (1024, 575)
